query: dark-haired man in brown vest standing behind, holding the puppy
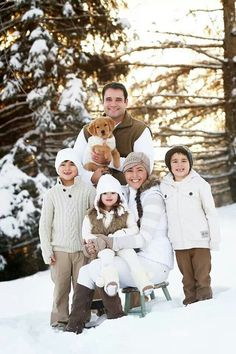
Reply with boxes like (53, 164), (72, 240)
(74, 82), (154, 185)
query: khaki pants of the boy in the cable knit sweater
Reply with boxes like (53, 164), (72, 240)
(50, 251), (85, 325)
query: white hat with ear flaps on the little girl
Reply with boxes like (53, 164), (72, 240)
(94, 174), (128, 219)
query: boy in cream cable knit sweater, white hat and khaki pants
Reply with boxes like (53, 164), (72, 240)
(39, 148), (95, 329)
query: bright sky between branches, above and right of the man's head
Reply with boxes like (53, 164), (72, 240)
(120, 0), (223, 98)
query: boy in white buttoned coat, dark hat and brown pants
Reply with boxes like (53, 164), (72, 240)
(161, 145), (220, 305)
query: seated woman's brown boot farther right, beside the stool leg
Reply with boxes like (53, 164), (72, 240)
(98, 288), (126, 319)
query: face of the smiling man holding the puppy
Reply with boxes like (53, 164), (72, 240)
(103, 88), (128, 123)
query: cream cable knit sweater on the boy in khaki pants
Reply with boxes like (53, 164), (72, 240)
(39, 177), (96, 264)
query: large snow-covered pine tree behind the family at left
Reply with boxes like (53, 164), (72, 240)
(0, 0), (127, 280)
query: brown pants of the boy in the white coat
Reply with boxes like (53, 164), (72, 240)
(175, 248), (212, 305)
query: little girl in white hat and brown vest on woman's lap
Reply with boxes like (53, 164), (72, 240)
(82, 174), (153, 296)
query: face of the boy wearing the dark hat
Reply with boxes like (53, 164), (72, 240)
(170, 152), (190, 181)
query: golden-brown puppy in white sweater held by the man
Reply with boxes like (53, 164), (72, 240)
(84, 117), (120, 171)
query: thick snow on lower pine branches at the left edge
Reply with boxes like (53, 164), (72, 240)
(0, 151), (47, 239)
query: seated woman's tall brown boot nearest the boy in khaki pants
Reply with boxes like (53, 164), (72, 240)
(65, 284), (94, 334)
